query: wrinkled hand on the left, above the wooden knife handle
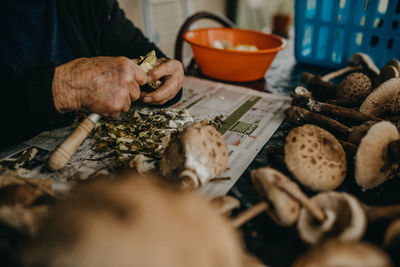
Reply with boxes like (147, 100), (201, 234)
(52, 57), (147, 118)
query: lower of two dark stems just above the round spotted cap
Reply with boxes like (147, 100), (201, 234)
(285, 106), (352, 137)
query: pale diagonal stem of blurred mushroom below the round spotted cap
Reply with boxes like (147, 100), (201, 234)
(275, 180), (326, 222)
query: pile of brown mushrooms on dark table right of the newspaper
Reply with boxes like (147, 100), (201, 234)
(238, 53), (400, 266)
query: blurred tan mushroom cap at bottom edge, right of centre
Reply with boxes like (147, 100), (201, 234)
(292, 241), (393, 267)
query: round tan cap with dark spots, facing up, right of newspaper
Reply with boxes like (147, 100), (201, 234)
(284, 124), (347, 191)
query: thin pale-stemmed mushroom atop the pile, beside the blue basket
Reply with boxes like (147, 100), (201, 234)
(322, 53), (379, 81)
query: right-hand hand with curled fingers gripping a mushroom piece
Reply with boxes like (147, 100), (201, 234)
(141, 58), (184, 105)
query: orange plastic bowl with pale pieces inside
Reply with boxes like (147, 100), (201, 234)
(183, 28), (286, 82)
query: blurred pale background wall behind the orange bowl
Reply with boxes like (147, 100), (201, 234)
(118, 0), (293, 57)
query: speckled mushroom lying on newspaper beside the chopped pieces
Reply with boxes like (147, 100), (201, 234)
(160, 123), (228, 189)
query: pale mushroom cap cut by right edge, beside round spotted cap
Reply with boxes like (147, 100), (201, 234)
(354, 121), (400, 189)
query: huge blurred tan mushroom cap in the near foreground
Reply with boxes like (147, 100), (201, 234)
(24, 176), (244, 267)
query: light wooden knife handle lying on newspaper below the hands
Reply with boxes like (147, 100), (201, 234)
(48, 113), (100, 171)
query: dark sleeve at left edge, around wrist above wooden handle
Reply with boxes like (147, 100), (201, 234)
(0, 63), (72, 148)
